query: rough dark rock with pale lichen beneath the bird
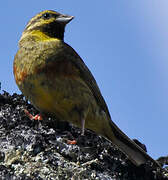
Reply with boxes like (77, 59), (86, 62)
(0, 92), (168, 180)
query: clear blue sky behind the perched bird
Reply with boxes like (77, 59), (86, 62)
(0, 0), (168, 158)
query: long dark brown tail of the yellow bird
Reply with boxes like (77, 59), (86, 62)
(105, 120), (161, 167)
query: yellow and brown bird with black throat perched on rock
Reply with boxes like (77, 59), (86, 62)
(13, 10), (160, 167)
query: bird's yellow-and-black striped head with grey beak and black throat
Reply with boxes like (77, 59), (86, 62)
(21, 10), (74, 40)
